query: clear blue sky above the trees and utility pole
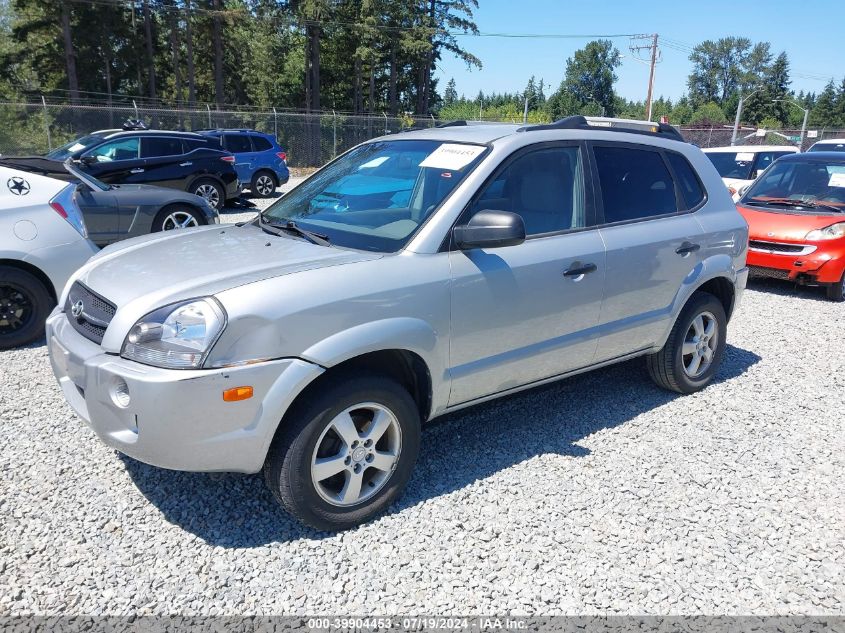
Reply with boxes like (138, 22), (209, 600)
(436, 0), (845, 101)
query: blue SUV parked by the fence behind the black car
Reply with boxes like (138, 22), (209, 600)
(200, 130), (290, 197)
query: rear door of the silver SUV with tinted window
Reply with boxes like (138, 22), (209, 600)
(591, 142), (704, 362)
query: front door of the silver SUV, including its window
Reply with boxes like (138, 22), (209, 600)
(449, 143), (605, 405)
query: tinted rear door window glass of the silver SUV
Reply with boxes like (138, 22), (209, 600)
(593, 145), (678, 223)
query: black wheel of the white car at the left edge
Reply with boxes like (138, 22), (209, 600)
(0, 266), (55, 349)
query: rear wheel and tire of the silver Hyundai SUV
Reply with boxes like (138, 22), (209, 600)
(646, 292), (728, 393)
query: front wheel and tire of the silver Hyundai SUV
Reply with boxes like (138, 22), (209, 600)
(264, 372), (420, 531)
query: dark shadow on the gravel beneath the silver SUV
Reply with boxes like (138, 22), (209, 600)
(120, 345), (761, 548)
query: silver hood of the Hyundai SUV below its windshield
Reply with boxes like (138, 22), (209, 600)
(76, 225), (381, 309)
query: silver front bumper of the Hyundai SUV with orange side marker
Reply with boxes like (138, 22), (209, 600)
(46, 308), (323, 473)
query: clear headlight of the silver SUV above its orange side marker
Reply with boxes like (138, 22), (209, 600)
(120, 297), (226, 369)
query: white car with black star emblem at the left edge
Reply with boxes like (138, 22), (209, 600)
(0, 167), (98, 349)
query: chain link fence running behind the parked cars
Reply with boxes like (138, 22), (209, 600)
(0, 99), (845, 167)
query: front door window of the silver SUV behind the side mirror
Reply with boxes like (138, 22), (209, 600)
(471, 147), (586, 235)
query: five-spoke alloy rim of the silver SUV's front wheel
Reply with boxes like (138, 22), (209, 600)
(311, 402), (402, 506)
